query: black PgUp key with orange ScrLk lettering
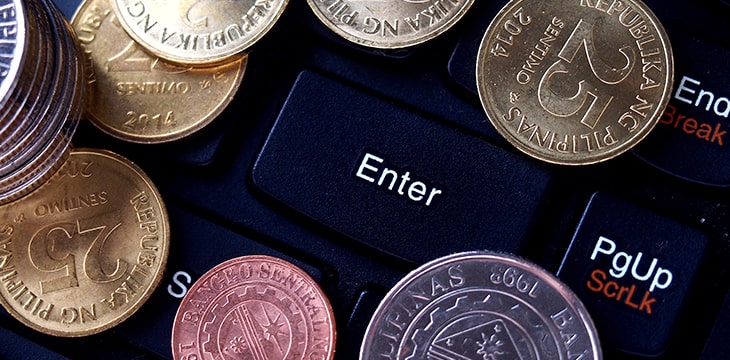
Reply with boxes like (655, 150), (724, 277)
(558, 193), (708, 356)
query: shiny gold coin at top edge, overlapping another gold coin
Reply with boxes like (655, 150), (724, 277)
(113, 0), (288, 64)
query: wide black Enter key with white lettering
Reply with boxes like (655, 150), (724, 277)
(253, 72), (549, 263)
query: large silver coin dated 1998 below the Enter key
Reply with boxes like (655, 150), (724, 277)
(360, 252), (602, 360)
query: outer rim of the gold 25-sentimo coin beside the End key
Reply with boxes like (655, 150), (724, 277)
(475, 0), (675, 166)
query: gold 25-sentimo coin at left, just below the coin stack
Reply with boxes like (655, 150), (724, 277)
(0, 149), (169, 337)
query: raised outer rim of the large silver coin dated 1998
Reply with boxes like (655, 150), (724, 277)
(358, 250), (603, 360)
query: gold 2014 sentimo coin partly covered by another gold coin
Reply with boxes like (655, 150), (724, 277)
(73, 0), (248, 143)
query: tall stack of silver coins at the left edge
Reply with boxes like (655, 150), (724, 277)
(0, 0), (85, 203)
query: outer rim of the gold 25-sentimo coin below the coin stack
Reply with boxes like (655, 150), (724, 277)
(0, 148), (170, 338)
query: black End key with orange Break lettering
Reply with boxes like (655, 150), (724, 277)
(634, 29), (730, 186)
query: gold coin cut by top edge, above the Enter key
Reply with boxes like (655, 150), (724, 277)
(307, 0), (474, 49)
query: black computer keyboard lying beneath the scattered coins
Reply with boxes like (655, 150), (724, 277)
(0, 0), (730, 360)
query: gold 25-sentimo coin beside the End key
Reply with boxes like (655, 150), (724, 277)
(477, 0), (674, 165)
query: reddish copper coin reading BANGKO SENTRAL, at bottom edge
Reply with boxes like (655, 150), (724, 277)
(172, 255), (335, 360)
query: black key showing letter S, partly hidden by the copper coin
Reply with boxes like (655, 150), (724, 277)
(114, 204), (322, 358)
